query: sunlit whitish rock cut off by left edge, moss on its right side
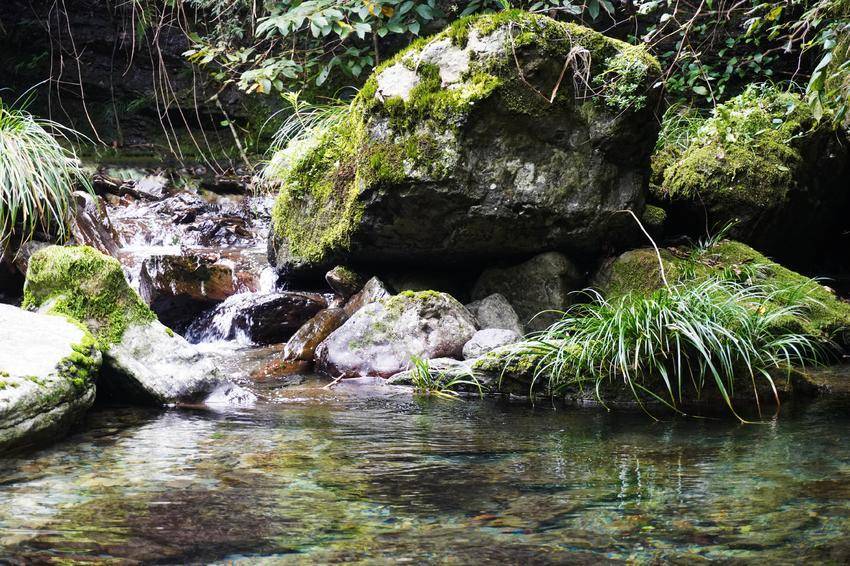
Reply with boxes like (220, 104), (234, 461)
(0, 305), (101, 452)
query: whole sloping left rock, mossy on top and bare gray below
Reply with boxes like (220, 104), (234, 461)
(23, 246), (247, 404)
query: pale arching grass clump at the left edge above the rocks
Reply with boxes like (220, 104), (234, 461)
(0, 101), (92, 249)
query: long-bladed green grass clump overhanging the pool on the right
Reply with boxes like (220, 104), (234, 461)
(516, 278), (828, 420)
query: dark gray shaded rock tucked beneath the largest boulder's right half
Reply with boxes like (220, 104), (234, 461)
(472, 252), (584, 330)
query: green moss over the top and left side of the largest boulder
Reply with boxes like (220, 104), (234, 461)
(265, 10), (660, 276)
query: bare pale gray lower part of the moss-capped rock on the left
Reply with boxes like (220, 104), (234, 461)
(98, 322), (251, 405)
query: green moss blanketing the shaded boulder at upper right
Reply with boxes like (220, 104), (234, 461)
(653, 86), (818, 209)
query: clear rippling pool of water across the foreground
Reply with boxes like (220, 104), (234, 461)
(0, 381), (850, 564)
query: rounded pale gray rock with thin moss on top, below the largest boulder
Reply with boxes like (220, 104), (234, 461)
(316, 291), (475, 377)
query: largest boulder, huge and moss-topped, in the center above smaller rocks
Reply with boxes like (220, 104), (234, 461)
(265, 11), (660, 273)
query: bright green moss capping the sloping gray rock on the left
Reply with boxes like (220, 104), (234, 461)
(22, 246), (156, 350)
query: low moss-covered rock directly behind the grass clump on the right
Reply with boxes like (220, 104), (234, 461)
(593, 240), (850, 347)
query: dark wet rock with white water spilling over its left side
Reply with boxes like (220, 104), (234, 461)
(187, 291), (328, 344)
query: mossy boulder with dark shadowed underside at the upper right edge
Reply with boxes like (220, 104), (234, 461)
(651, 86), (850, 263)
